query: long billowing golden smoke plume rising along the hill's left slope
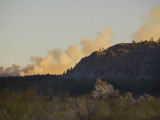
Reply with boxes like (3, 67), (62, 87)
(0, 27), (113, 76)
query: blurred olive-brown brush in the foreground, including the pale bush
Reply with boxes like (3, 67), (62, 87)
(0, 80), (160, 120)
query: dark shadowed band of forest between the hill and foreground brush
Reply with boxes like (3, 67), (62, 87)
(0, 75), (160, 96)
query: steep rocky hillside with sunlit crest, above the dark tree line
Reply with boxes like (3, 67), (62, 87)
(65, 41), (160, 79)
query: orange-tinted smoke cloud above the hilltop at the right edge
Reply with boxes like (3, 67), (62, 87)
(133, 6), (160, 41)
